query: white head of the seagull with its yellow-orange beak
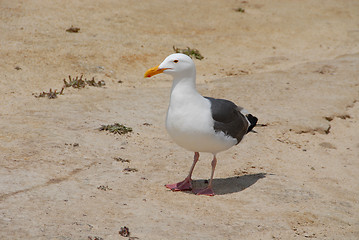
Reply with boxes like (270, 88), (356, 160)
(145, 53), (196, 77)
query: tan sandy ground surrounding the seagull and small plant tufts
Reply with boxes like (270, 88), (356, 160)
(0, 0), (359, 240)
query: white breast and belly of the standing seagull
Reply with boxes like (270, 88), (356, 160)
(166, 86), (237, 154)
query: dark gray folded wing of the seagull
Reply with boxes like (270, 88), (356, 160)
(205, 97), (249, 144)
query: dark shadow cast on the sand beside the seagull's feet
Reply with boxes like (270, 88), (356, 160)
(192, 173), (267, 195)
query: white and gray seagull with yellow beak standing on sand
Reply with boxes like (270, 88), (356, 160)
(145, 53), (258, 196)
